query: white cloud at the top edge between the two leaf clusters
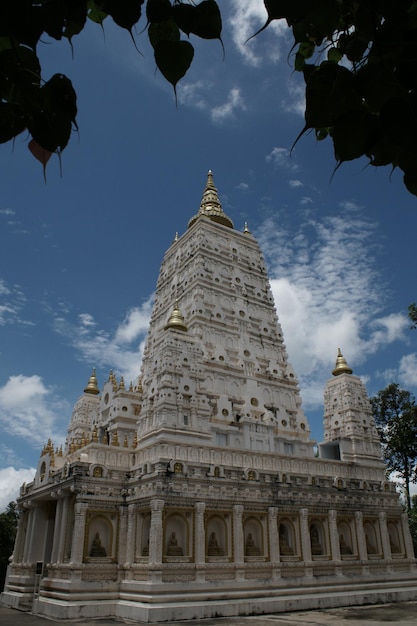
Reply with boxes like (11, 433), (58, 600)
(228, 0), (289, 67)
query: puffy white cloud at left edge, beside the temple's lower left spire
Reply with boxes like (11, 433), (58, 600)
(0, 374), (68, 447)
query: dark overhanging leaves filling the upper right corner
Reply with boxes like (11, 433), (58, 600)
(250, 0), (417, 195)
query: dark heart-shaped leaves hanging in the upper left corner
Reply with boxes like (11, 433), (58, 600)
(0, 0), (222, 168)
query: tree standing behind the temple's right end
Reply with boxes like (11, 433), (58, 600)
(371, 383), (417, 511)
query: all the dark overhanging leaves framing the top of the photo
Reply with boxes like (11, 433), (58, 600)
(0, 0), (417, 195)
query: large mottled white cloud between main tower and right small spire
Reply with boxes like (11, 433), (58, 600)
(256, 207), (406, 408)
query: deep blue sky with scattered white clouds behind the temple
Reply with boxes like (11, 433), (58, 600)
(0, 0), (417, 509)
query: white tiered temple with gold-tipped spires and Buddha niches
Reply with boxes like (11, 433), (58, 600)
(1, 172), (417, 622)
